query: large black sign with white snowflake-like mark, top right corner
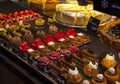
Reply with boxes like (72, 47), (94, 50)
(93, 0), (120, 17)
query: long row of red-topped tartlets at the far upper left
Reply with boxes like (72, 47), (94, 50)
(0, 10), (42, 26)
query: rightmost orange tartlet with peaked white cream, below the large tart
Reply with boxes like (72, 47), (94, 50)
(101, 53), (117, 68)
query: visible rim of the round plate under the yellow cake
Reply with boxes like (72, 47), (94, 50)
(53, 14), (116, 29)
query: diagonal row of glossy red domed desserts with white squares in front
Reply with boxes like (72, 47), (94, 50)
(20, 28), (86, 52)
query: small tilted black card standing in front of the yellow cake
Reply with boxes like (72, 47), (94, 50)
(87, 16), (100, 33)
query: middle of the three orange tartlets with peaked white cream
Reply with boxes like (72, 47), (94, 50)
(83, 61), (99, 77)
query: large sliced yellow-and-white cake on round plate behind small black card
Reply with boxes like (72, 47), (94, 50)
(54, 4), (111, 26)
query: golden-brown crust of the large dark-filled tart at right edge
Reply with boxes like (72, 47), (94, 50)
(100, 19), (120, 50)
